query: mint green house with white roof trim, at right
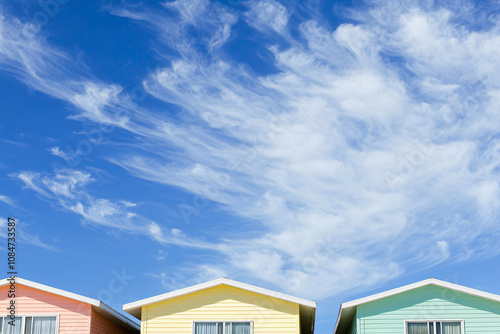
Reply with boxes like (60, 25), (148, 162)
(333, 278), (500, 334)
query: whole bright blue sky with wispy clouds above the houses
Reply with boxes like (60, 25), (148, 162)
(0, 0), (500, 333)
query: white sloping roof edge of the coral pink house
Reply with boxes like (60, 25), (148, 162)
(0, 277), (141, 330)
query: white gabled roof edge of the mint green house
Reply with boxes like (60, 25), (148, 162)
(333, 278), (500, 334)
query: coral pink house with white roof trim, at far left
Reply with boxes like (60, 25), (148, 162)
(0, 278), (140, 334)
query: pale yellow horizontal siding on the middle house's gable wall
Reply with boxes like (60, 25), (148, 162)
(141, 285), (300, 334)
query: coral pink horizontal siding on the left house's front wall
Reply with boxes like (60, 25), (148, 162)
(0, 283), (91, 334)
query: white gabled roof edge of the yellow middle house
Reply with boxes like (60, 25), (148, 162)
(123, 278), (316, 313)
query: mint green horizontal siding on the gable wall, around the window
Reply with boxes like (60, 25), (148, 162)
(350, 285), (500, 334)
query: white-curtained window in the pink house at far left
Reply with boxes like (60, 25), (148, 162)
(0, 316), (57, 334)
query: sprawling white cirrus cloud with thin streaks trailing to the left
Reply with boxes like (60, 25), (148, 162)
(0, 0), (500, 298)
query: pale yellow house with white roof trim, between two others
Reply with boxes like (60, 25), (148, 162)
(123, 278), (316, 334)
